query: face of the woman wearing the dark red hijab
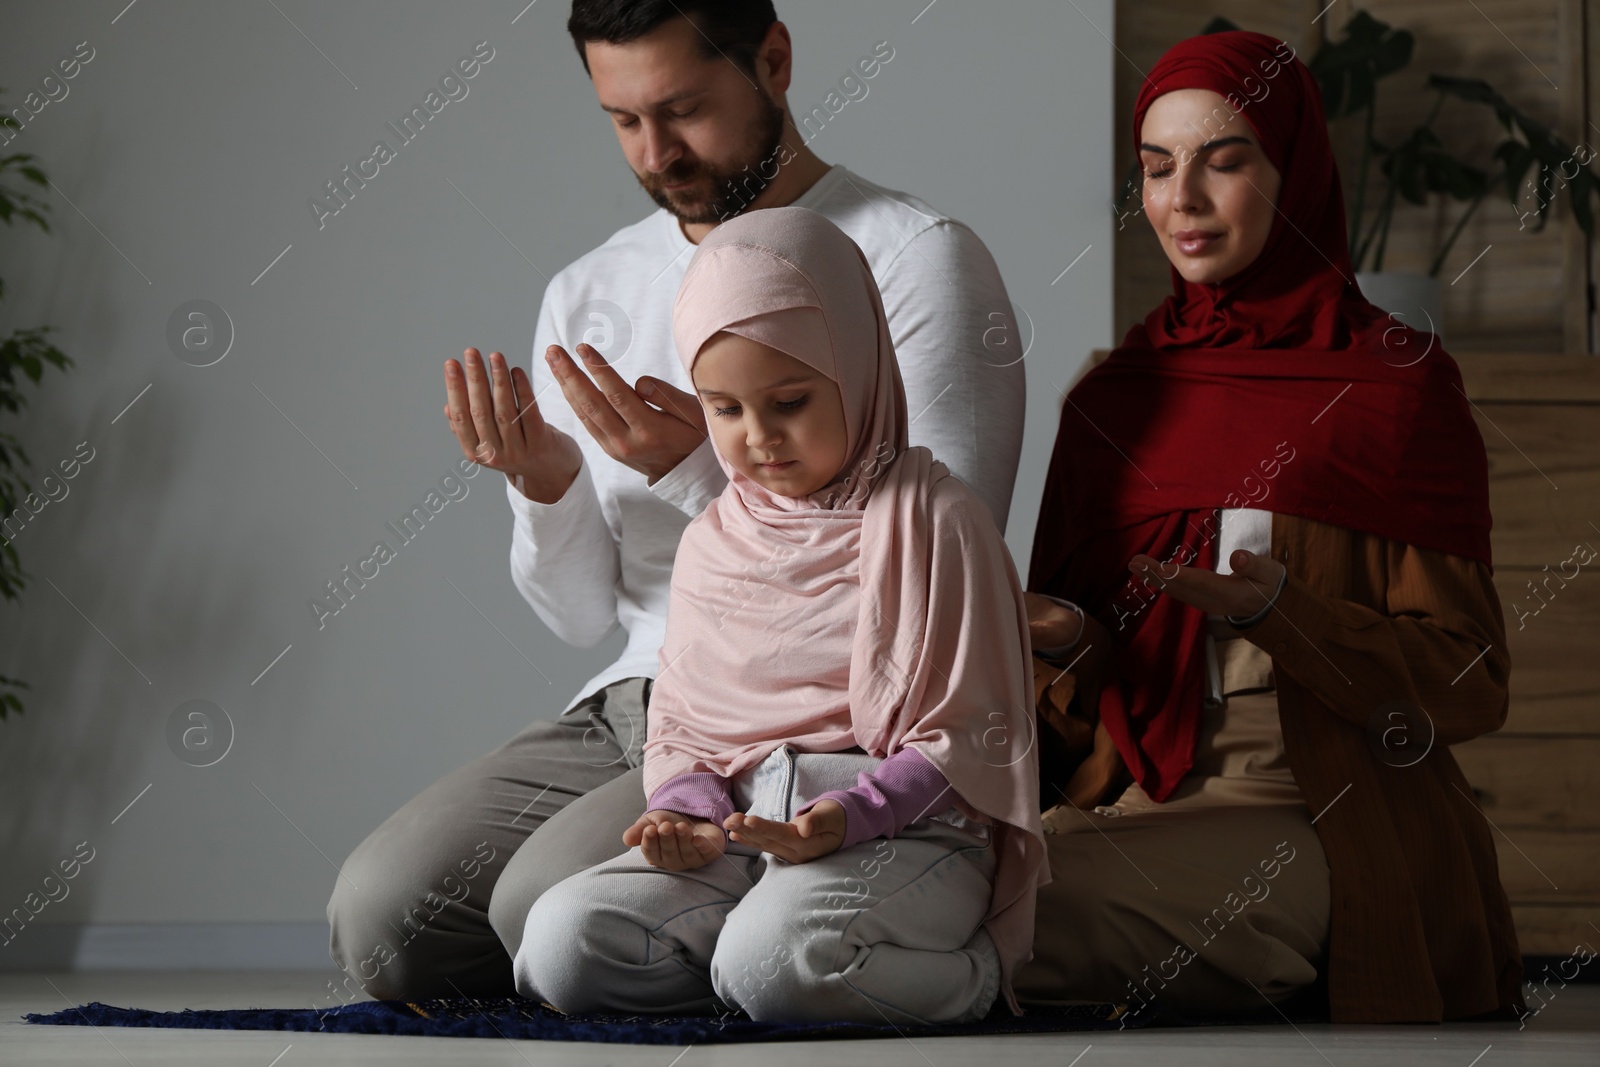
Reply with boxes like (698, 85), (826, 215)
(1139, 90), (1282, 285)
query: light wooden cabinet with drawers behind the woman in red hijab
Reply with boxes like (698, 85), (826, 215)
(1454, 354), (1600, 955)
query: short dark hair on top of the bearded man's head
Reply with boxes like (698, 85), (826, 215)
(566, 0), (778, 78)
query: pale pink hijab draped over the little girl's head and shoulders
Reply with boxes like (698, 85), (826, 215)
(645, 206), (1050, 1014)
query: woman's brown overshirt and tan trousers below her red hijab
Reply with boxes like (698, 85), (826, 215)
(1016, 514), (1522, 1022)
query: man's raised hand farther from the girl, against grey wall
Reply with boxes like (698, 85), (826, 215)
(445, 349), (582, 504)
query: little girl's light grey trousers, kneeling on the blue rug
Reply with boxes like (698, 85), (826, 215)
(514, 745), (1000, 1024)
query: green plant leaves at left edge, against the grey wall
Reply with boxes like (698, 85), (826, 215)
(0, 90), (72, 718)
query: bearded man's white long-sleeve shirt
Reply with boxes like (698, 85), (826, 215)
(506, 166), (1026, 709)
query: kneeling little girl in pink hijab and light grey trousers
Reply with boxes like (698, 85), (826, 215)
(515, 206), (1050, 1024)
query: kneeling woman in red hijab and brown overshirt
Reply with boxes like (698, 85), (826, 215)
(1018, 32), (1522, 1022)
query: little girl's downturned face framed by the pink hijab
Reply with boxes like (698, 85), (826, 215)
(693, 331), (845, 496)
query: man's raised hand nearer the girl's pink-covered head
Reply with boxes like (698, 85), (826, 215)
(544, 344), (706, 485)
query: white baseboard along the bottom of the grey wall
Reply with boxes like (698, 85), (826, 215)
(0, 923), (333, 971)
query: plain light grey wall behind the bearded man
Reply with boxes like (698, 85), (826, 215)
(0, 0), (1112, 966)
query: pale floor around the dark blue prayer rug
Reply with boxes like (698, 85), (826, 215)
(0, 971), (1600, 1067)
